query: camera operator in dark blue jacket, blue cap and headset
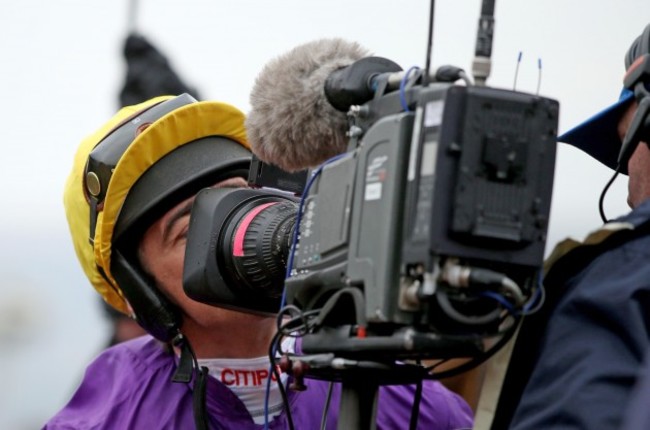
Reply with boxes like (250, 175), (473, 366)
(511, 25), (650, 429)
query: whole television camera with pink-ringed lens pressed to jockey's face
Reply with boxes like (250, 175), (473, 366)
(184, 2), (559, 426)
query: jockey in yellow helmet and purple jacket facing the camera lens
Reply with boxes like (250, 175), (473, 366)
(45, 94), (472, 429)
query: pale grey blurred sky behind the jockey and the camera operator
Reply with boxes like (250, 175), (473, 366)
(0, 0), (650, 429)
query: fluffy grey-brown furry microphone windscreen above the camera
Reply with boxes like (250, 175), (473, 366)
(245, 38), (370, 172)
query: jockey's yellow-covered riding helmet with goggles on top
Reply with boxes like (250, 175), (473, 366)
(64, 94), (251, 340)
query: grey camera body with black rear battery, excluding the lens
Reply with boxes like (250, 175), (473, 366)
(286, 84), (559, 350)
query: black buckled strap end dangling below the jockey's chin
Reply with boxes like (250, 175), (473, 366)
(172, 332), (209, 430)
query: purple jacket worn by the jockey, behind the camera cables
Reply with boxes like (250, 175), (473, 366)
(43, 336), (473, 430)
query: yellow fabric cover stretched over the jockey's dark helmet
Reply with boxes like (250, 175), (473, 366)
(63, 96), (250, 314)
